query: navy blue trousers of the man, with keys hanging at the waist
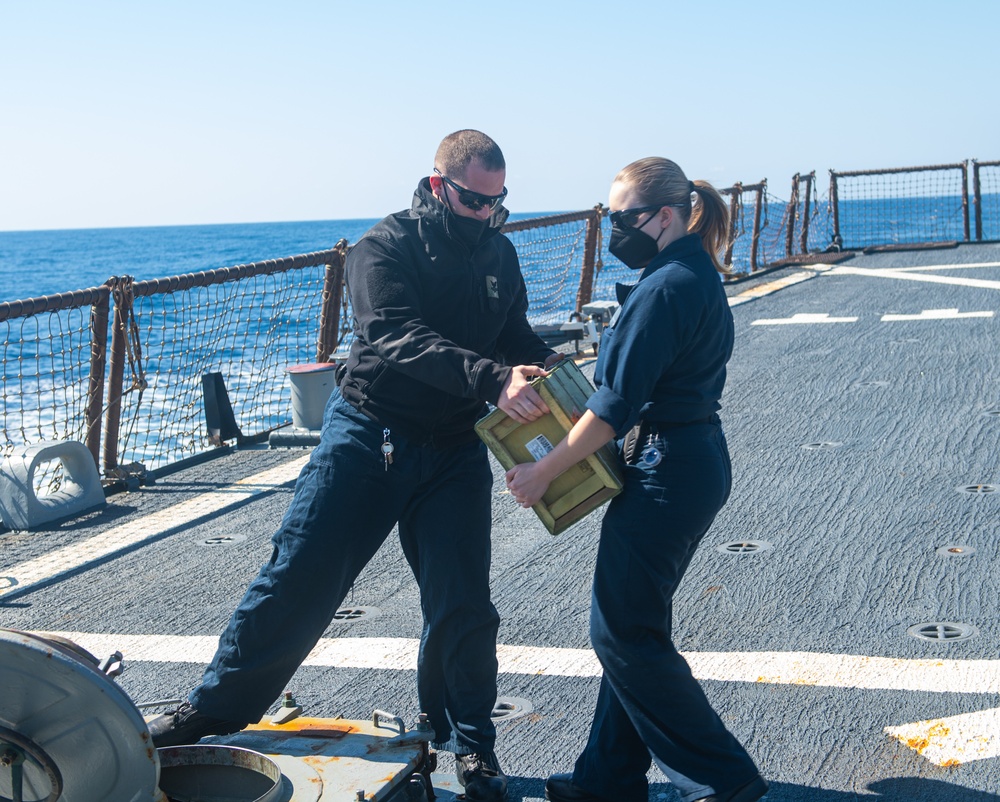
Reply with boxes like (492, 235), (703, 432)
(189, 390), (500, 752)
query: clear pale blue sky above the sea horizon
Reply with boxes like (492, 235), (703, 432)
(0, 0), (1000, 231)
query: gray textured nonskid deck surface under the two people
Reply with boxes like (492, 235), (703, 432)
(0, 245), (1000, 802)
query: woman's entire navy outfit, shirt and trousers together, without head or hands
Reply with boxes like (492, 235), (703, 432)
(573, 235), (757, 802)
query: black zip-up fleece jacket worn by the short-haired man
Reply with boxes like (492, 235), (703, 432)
(339, 178), (553, 446)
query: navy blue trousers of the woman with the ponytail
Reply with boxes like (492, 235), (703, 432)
(573, 423), (757, 802)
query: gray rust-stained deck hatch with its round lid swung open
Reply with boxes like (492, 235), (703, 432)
(0, 629), (438, 802)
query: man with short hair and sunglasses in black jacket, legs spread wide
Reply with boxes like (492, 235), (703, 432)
(150, 130), (560, 802)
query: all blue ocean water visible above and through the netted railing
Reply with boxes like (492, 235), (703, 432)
(0, 194), (1000, 469)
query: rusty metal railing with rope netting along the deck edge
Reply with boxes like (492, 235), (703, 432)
(0, 155), (1000, 481)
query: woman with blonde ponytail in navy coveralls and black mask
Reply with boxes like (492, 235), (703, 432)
(507, 158), (767, 802)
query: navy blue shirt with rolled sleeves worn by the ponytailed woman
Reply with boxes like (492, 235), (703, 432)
(587, 234), (733, 437)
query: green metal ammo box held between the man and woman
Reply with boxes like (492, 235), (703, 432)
(476, 359), (622, 535)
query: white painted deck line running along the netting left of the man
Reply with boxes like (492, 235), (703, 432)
(0, 455), (309, 596)
